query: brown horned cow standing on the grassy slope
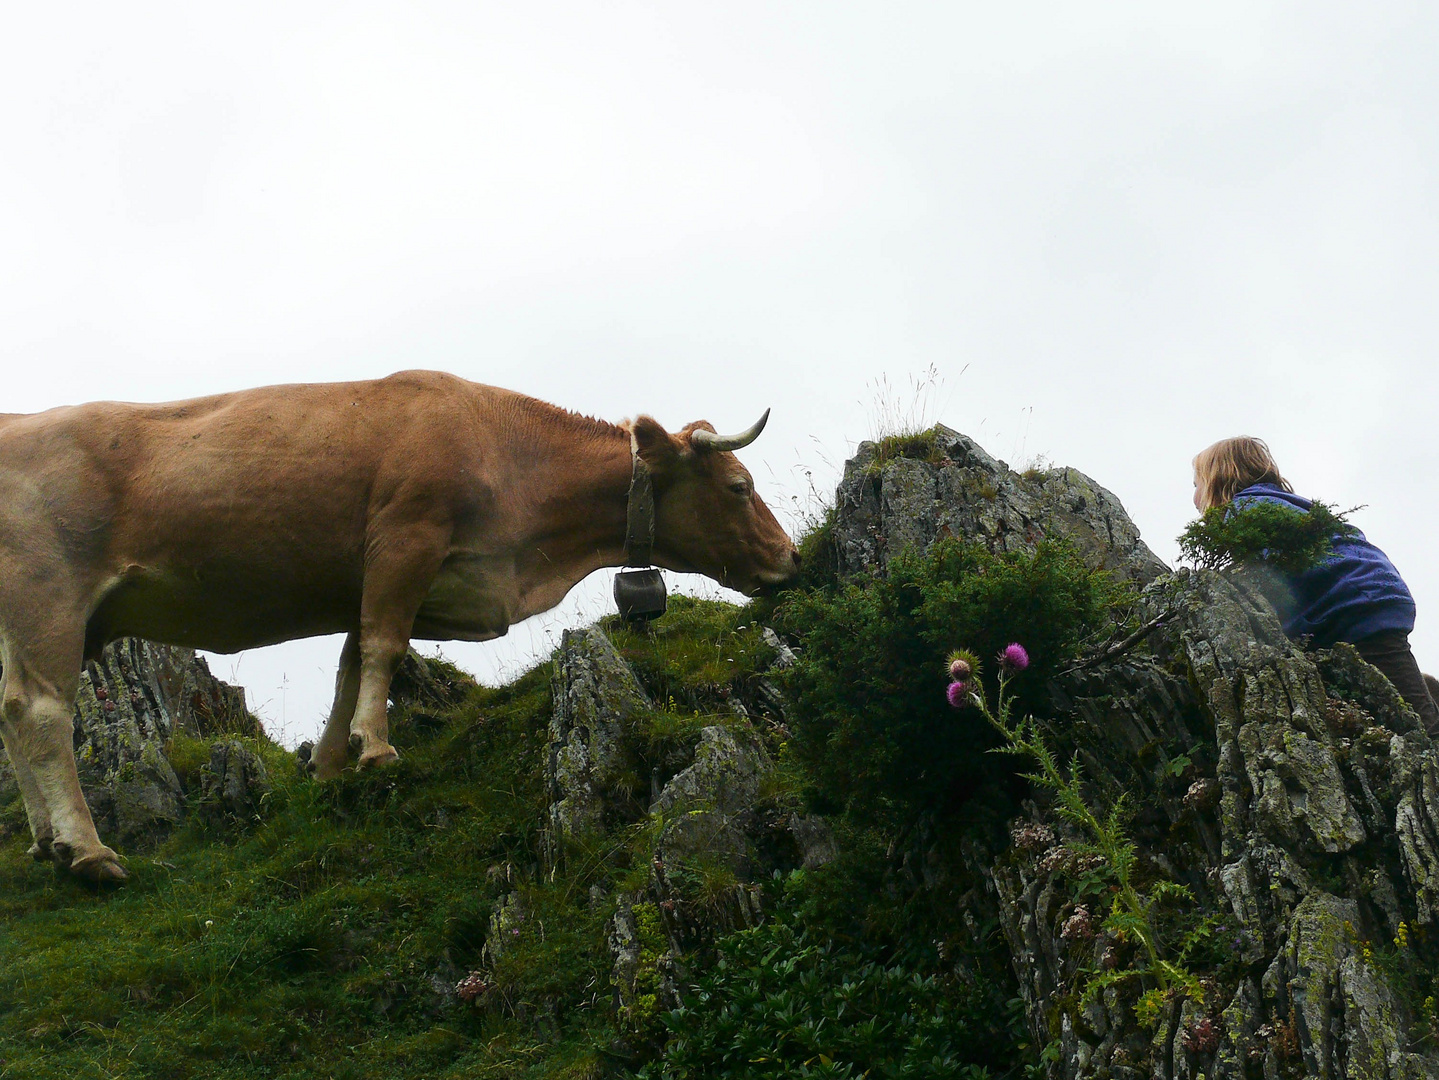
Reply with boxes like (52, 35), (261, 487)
(0, 371), (799, 880)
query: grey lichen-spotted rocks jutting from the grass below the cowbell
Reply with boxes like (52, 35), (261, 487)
(538, 627), (817, 1018)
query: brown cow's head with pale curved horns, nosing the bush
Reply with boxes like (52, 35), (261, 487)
(630, 410), (800, 595)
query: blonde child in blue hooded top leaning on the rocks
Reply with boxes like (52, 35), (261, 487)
(1194, 437), (1439, 735)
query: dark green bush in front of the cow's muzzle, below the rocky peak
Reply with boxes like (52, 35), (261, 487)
(777, 541), (1122, 824)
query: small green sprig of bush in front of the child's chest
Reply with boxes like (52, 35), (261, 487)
(1179, 502), (1354, 574)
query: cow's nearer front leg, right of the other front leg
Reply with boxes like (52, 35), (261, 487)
(350, 526), (449, 769)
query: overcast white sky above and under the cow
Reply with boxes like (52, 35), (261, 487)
(0, 0), (1439, 743)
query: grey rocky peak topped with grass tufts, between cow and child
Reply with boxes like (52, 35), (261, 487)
(835, 424), (1167, 584)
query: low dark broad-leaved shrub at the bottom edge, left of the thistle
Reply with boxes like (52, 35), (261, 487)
(639, 922), (990, 1080)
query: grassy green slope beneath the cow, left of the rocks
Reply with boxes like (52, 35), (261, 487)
(0, 658), (561, 1077)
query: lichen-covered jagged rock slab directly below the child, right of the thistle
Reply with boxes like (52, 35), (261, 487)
(1157, 574), (1439, 1077)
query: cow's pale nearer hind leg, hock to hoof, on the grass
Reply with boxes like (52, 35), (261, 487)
(0, 639), (125, 882)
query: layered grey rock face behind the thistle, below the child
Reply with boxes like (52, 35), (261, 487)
(987, 572), (1439, 1077)
